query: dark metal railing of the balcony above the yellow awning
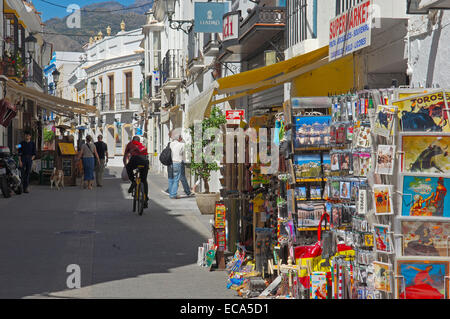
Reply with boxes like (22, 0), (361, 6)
(240, 6), (286, 34)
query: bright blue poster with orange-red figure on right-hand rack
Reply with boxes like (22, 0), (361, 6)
(401, 175), (450, 217)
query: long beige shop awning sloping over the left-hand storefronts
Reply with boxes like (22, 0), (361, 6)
(6, 79), (97, 116)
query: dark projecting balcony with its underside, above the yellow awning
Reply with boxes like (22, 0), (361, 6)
(239, 6), (286, 59)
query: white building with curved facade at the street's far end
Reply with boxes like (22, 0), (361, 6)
(69, 22), (145, 157)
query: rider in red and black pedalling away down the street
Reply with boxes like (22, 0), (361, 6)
(123, 136), (150, 208)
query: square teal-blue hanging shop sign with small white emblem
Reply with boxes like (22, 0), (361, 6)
(194, 2), (225, 33)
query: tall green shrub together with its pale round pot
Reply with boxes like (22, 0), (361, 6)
(190, 106), (227, 215)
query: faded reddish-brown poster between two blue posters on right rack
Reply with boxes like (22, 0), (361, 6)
(401, 220), (450, 257)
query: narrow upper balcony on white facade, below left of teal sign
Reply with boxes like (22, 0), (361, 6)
(160, 49), (183, 90)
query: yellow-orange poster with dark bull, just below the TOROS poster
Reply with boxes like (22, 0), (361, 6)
(401, 134), (450, 174)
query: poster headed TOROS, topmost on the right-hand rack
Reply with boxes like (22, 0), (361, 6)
(393, 91), (450, 132)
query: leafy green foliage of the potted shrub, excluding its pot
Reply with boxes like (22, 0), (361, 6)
(189, 106), (227, 193)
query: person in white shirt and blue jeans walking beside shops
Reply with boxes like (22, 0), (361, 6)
(169, 134), (193, 199)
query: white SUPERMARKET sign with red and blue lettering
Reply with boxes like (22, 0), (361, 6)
(328, 0), (373, 61)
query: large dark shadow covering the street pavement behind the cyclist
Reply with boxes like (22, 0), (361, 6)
(0, 172), (216, 298)
